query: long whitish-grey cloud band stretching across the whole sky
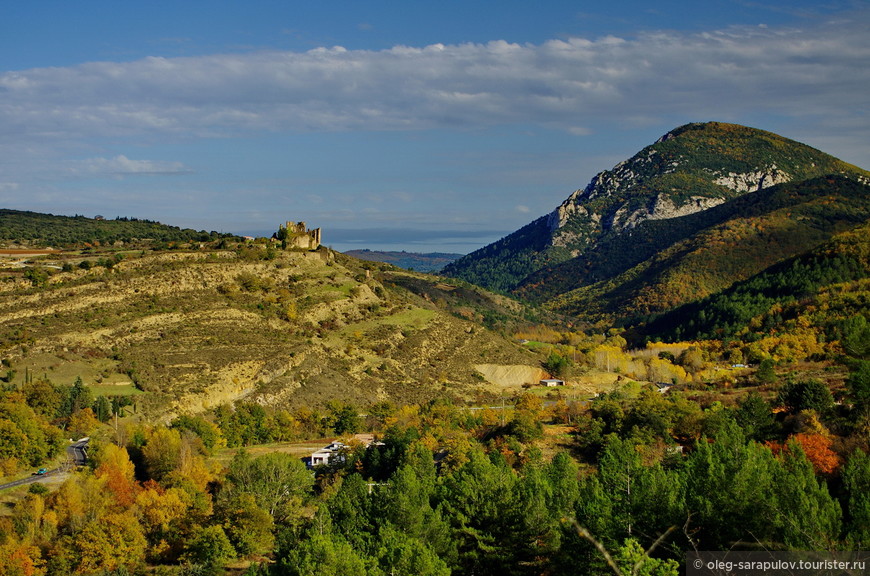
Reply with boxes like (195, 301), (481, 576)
(0, 11), (870, 144)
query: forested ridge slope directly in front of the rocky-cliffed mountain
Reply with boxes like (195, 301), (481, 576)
(544, 176), (870, 324)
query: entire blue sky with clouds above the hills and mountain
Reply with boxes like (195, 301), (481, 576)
(0, 0), (870, 252)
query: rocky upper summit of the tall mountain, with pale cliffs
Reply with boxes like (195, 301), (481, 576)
(547, 122), (860, 246)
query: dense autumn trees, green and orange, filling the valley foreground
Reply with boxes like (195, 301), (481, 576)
(0, 363), (870, 576)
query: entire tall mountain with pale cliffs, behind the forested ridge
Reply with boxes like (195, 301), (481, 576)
(444, 122), (870, 310)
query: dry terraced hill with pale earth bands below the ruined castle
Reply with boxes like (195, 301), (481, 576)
(0, 244), (540, 413)
